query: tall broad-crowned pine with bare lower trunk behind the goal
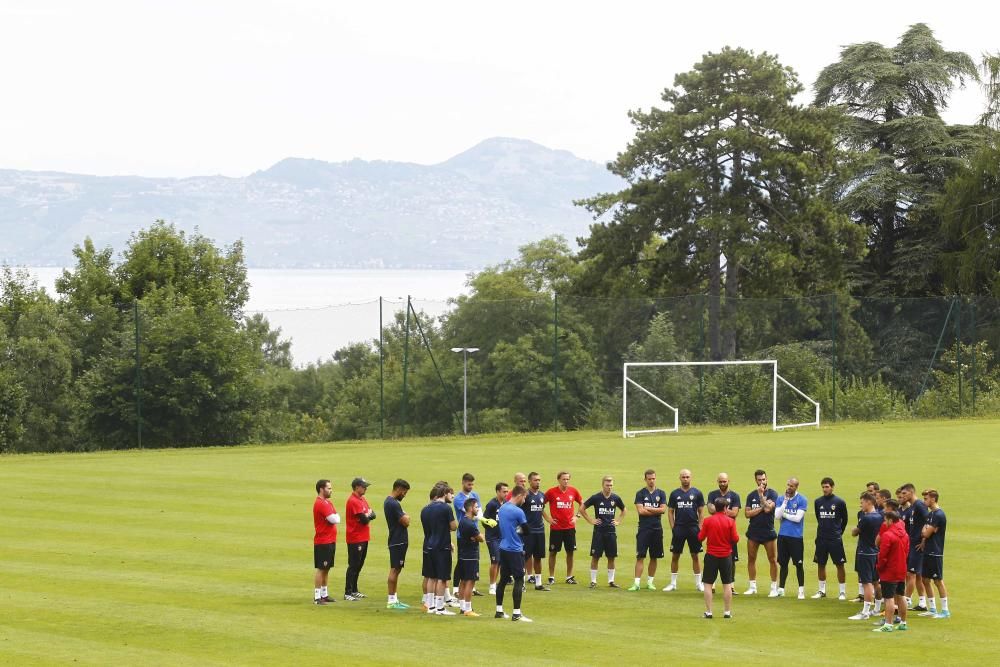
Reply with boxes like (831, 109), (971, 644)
(580, 47), (861, 359)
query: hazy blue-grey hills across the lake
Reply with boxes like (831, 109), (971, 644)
(0, 138), (621, 269)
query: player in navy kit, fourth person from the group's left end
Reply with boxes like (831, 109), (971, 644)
(420, 482), (458, 616)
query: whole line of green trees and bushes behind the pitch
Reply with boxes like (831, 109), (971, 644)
(0, 24), (1000, 451)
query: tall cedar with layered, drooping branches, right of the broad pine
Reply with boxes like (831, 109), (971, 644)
(815, 23), (982, 296)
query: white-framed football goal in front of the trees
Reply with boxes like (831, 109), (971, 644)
(622, 359), (819, 438)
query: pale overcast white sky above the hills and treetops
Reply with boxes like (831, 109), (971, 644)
(0, 0), (1000, 177)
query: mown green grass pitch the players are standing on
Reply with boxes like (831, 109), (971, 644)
(0, 420), (1000, 665)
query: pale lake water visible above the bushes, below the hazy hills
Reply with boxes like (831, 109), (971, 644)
(27, 267), (468, 365)
